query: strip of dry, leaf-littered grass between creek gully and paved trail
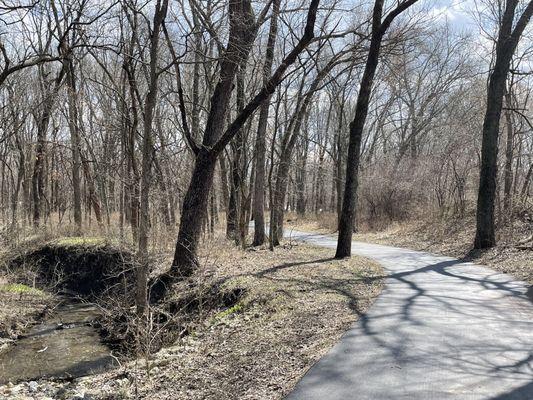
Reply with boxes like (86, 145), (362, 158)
(0, 234), (382, 400)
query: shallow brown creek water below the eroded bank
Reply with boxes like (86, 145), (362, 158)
(0, 300), (116, 384)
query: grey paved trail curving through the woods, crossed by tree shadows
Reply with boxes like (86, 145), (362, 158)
(287, 231), (533, 400)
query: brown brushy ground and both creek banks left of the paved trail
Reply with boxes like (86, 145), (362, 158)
(0, 231), (383, 399)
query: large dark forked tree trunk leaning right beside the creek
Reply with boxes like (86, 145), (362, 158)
(169, 0), (319, 277)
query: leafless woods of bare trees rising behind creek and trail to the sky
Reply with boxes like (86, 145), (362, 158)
(0, 0), (533, 322)
